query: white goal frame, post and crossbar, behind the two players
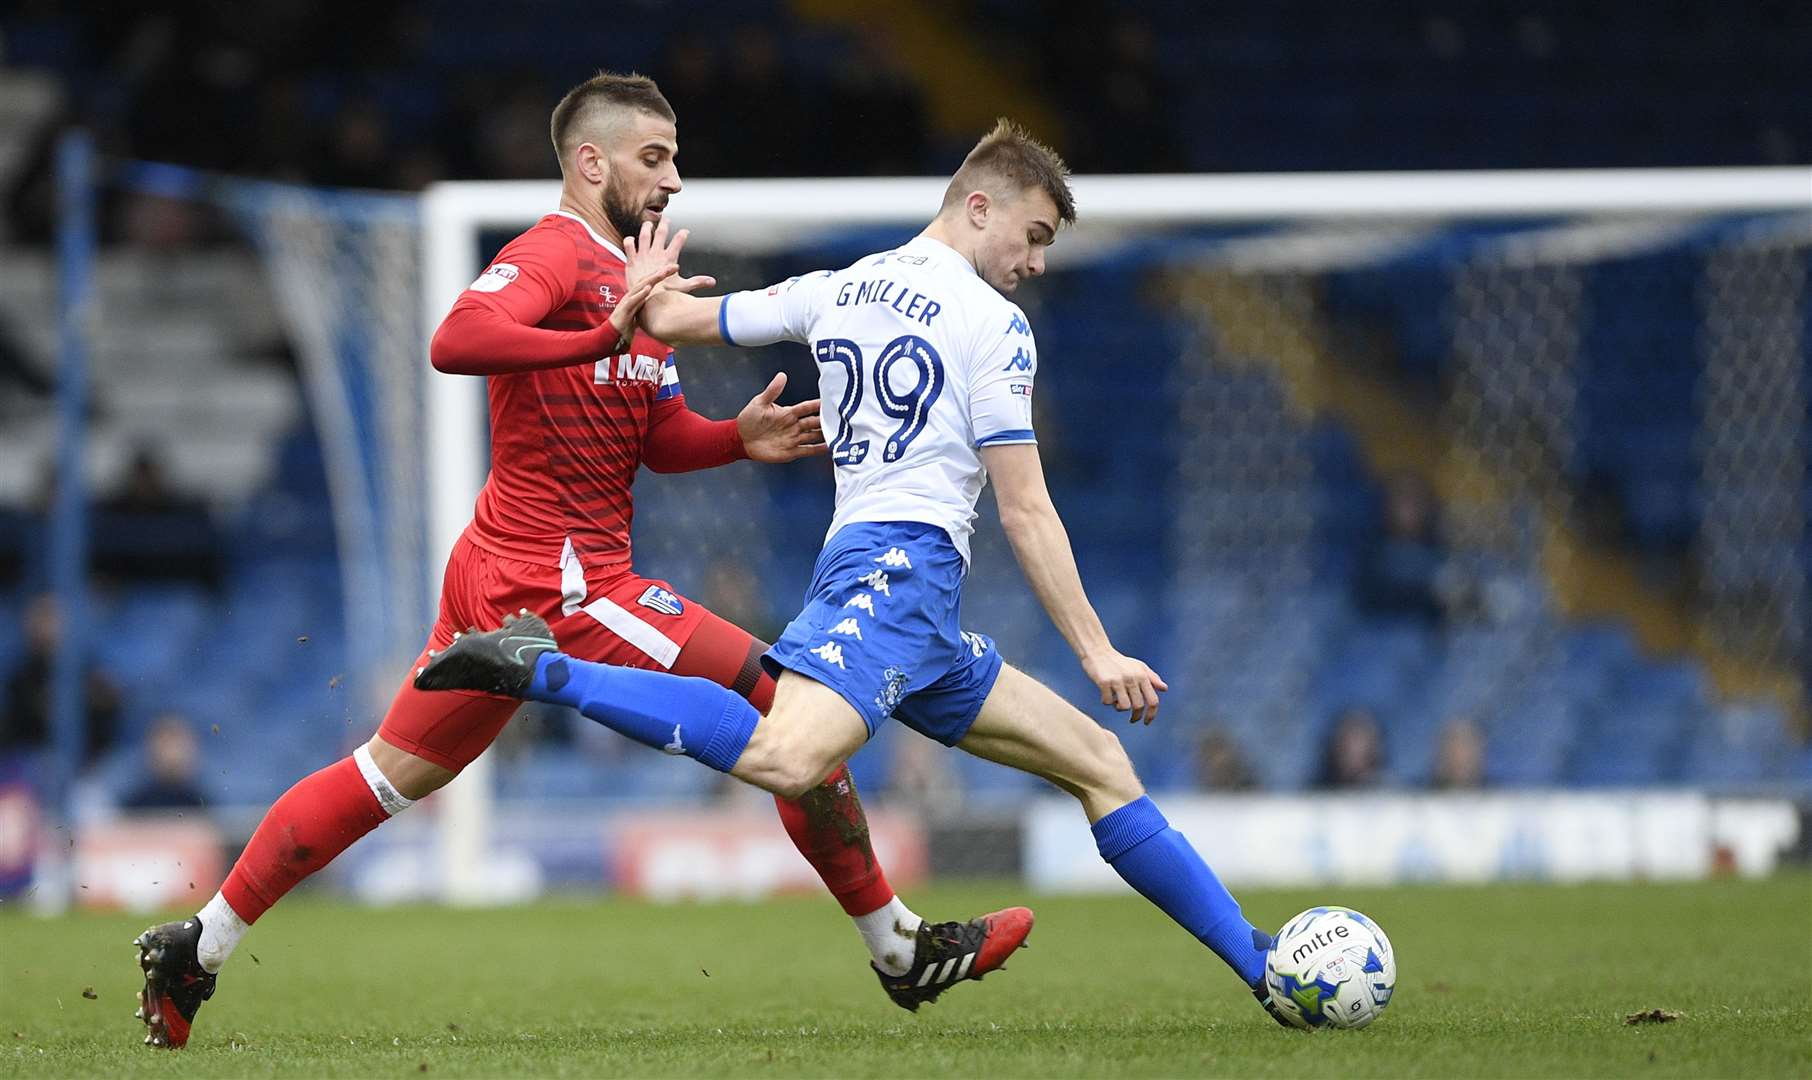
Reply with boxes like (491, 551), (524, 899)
(419, 167), (1812, 902)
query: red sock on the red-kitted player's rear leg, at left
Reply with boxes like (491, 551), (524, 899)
(221, 757), (390, 922)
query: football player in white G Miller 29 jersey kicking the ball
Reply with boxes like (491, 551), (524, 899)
(417, 120), (1281, 1022)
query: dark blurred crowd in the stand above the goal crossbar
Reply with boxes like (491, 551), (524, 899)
(0, 0), (1812, 237)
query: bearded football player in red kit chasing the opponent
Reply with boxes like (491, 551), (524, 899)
(136, 74), (1031, 1047)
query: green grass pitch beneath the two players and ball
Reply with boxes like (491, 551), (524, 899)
(0, 875), (1812, 1080)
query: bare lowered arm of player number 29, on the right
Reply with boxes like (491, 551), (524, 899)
(982, 442), (1171, 723)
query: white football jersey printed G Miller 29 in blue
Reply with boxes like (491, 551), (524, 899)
(718, 236), (1038, 562)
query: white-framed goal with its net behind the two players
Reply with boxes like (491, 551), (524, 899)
(244, 169), (1812, 897)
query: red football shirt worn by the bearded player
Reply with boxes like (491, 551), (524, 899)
(437, 210), (741, 569)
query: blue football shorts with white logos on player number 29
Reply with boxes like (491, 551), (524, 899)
(761, 522), (1000, 747)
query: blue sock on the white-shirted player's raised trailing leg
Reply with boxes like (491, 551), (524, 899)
(527, 652), (761, 772)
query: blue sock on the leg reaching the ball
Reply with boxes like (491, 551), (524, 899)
(1093, 796), (1270, 986)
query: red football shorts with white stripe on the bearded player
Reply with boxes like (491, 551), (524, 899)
(379, 536), (774, 772)
